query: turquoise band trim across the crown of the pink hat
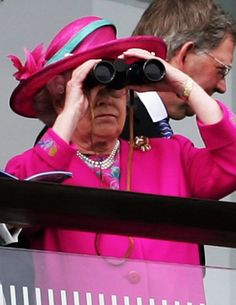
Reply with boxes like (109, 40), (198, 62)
(46, 19), (115, 65)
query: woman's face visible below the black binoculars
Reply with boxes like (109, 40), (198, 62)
(76, 87), (127, 142)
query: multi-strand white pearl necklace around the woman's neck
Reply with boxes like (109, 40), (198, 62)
(76, 140), (120, 169)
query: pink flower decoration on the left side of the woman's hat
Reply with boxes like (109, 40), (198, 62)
(8, 43), (45, 80)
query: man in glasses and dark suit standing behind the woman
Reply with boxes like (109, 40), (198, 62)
(123, 0), (236, 138)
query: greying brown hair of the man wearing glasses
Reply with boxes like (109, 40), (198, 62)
(133, 0), (236, 58)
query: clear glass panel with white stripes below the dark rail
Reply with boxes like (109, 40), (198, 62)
(0, 248), (236, 305)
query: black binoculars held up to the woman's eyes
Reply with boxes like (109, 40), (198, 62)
(85, 58), (165, 90)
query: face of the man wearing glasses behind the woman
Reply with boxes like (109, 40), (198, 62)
(160, 37), (235, 120)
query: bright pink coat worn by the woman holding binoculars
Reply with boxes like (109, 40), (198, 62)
(6, 101), (236, 264)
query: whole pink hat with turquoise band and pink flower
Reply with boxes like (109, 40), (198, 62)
(9, 16), (166, 118)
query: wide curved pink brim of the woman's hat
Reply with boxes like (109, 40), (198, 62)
(10, 36), (167, 118)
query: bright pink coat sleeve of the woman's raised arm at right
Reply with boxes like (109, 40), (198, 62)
(183, 103), (236, 199)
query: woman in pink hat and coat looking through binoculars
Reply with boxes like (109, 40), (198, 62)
(6, 17), (236, 304)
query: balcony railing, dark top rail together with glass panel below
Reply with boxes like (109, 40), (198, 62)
(0, 180), (236, 305)
